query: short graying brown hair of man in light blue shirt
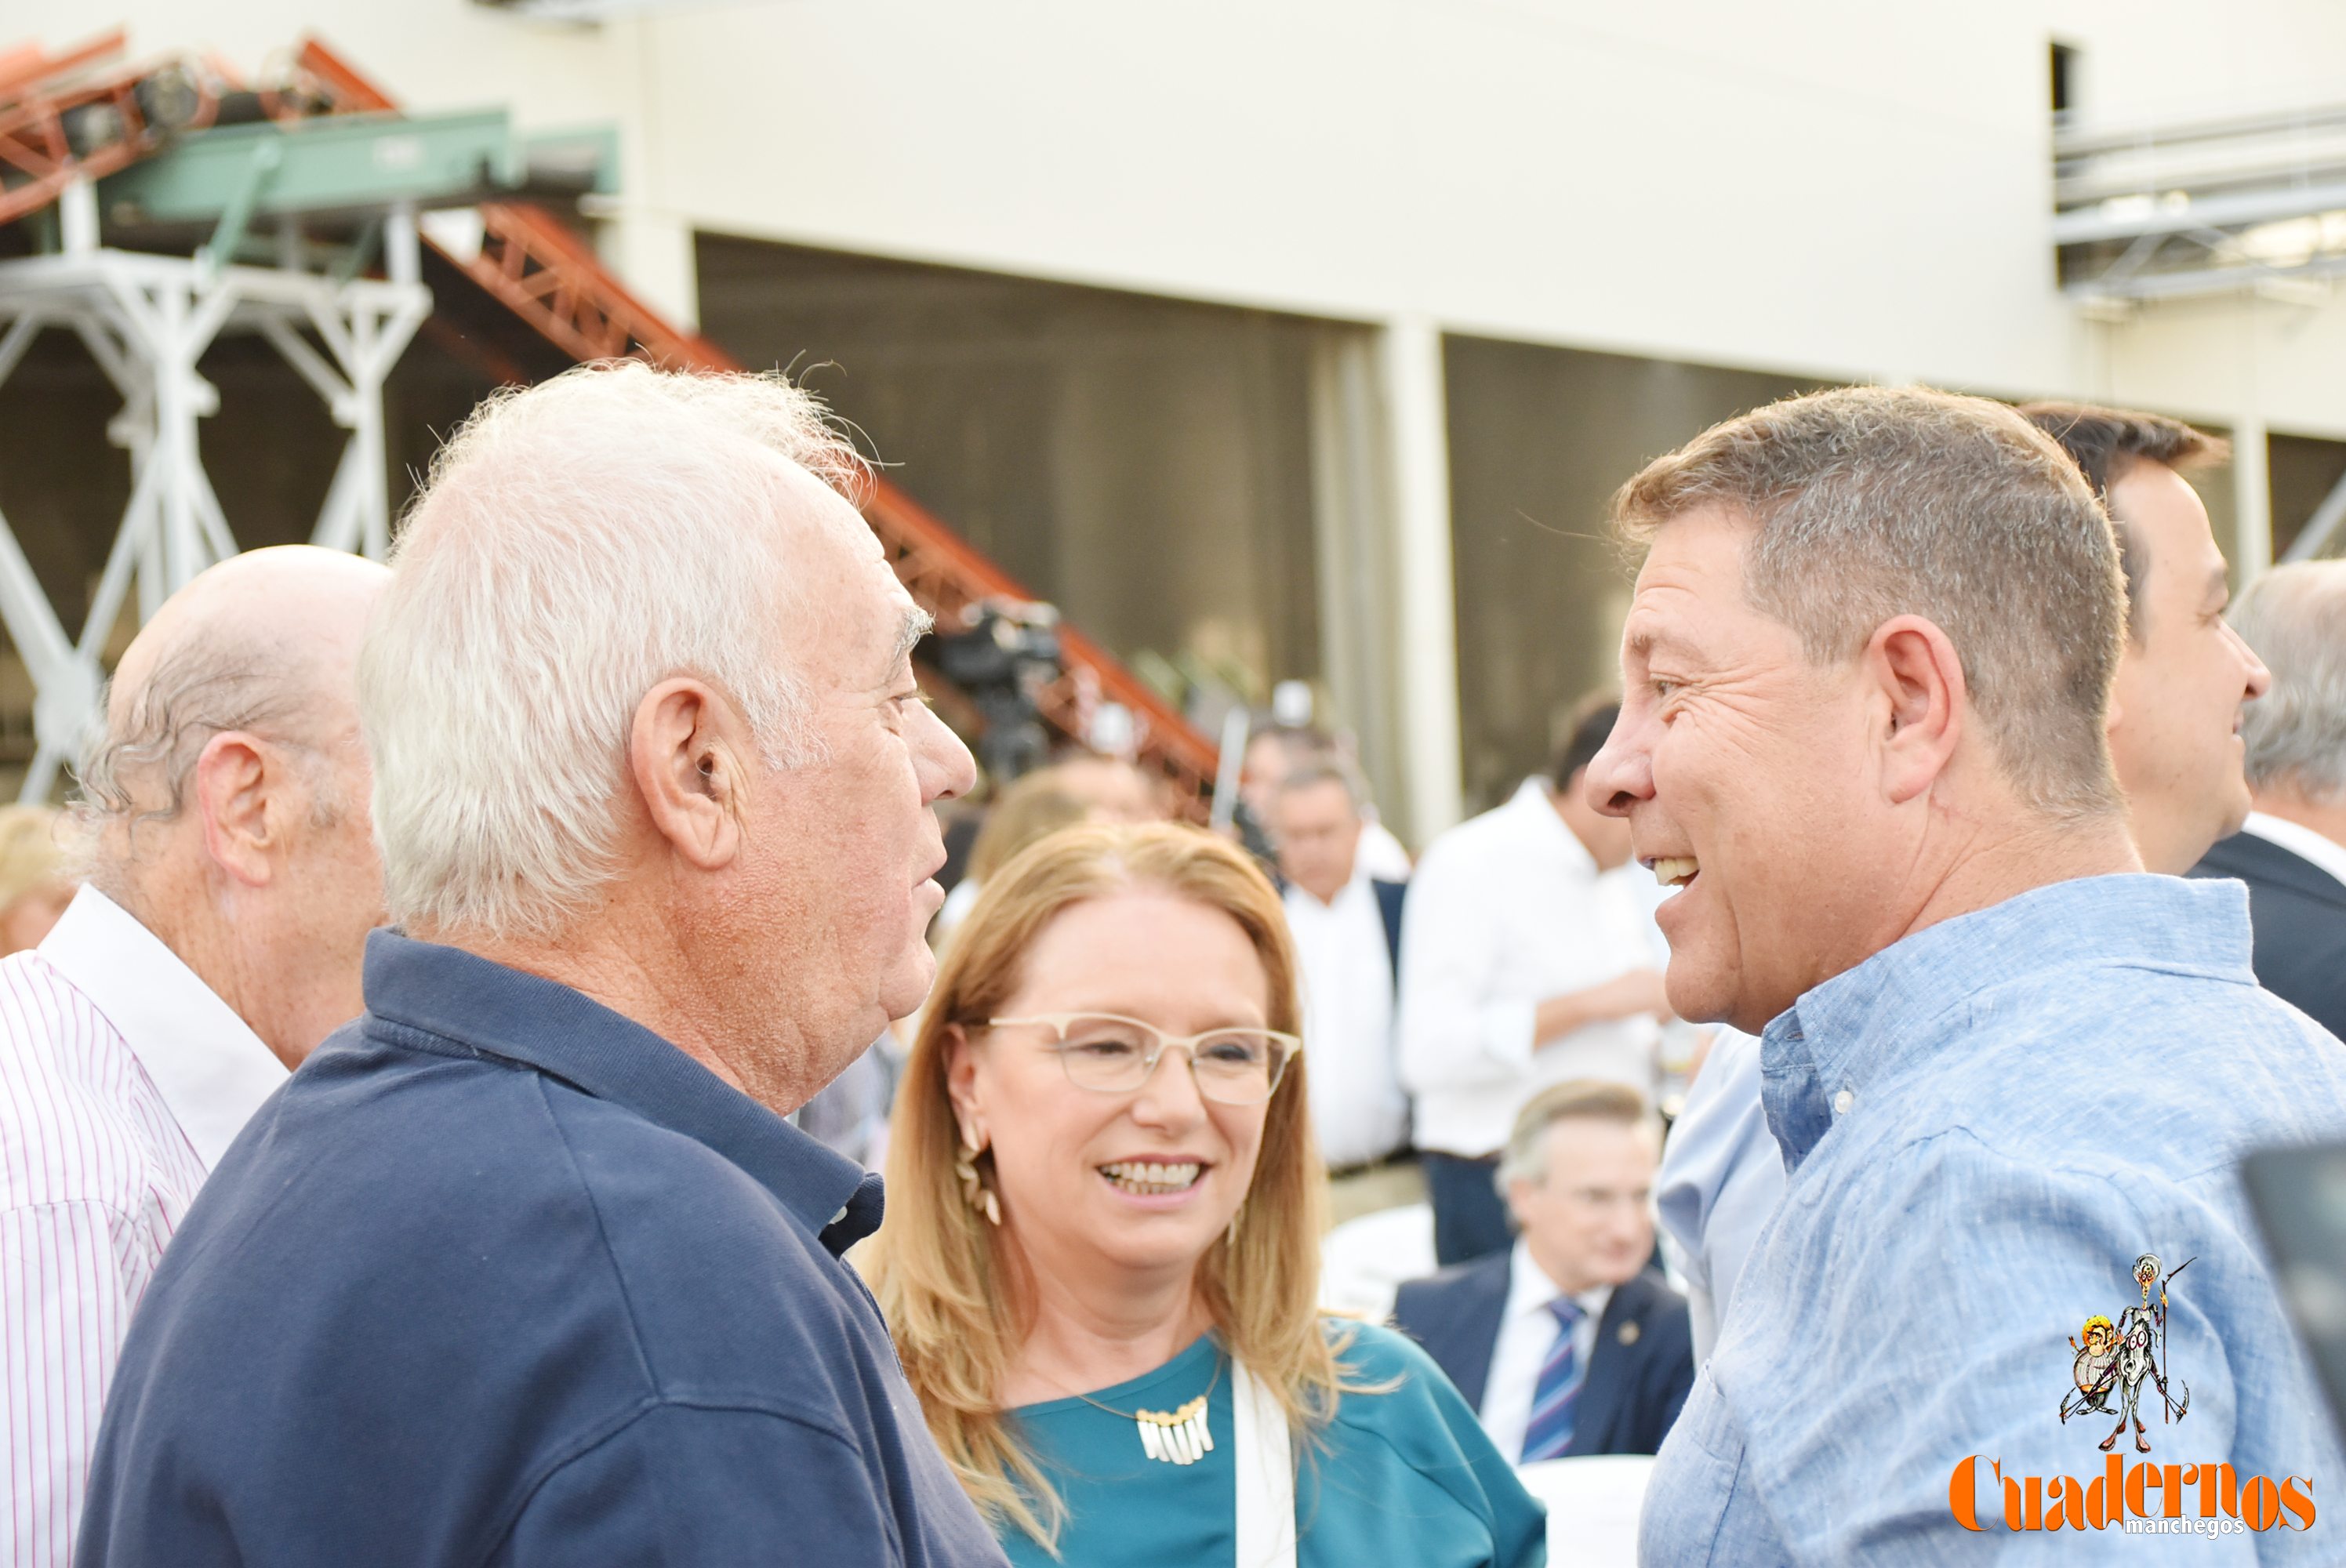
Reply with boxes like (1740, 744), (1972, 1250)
(1614, 387), (2126, 817)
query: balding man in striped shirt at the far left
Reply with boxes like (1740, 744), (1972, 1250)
(0, 545), (390, 1568)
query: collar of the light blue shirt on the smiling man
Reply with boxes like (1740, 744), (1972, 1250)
(1760, 873), (2257, 1167)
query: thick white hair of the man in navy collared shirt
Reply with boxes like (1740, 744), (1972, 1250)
(359, 361), (868, 937)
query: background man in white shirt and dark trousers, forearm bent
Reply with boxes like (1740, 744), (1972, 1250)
(1400, 699), (1668, 1265)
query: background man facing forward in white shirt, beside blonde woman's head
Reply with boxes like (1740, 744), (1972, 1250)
(1269, 756), (1417, 1223)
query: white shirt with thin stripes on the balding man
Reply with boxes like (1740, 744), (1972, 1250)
(0, 887), (286, 1568)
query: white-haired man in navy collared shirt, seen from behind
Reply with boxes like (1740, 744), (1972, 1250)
(82, 364), (1002, 1568)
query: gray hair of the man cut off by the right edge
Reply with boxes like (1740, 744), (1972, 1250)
(2231, 561), (2346, 798)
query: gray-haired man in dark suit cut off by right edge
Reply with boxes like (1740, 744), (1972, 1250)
(2194, 561), (2346, 1037)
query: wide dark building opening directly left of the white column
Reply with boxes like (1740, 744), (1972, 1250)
(699, 234), (1320, 718)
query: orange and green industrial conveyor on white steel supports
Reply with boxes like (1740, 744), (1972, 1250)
(0, 33), (1215, 810)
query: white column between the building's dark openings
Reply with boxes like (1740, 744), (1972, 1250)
(1377, 317), (1464, 848)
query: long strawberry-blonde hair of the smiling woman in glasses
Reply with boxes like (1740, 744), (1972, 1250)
(868, 822), (1349, 1549)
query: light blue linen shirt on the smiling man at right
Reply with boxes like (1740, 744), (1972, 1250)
(1640, 876), (2346, 1568)
